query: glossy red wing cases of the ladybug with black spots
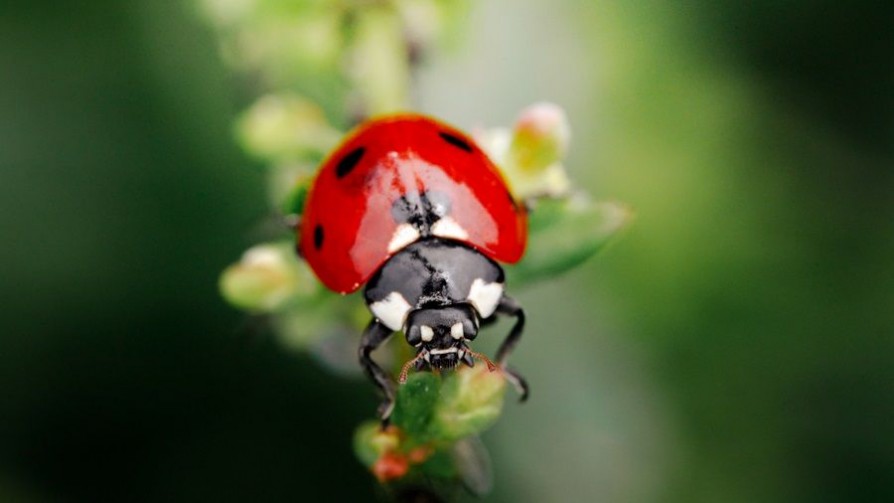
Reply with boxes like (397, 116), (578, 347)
(298, 114), (527, 293)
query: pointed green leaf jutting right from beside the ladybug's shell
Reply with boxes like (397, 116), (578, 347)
(506, 197), (631, 286)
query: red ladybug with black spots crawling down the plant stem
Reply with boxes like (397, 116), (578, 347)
(298, 114), (528, 421)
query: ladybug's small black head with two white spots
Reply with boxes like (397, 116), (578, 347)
(406, 304), (478, 369)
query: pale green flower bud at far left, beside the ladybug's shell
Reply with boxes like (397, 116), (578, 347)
(220, 244), (317, 312)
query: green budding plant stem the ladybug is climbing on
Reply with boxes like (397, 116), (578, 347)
(201, 0), (629, 494)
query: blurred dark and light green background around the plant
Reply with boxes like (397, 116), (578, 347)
(0, 0), (894, 502)
